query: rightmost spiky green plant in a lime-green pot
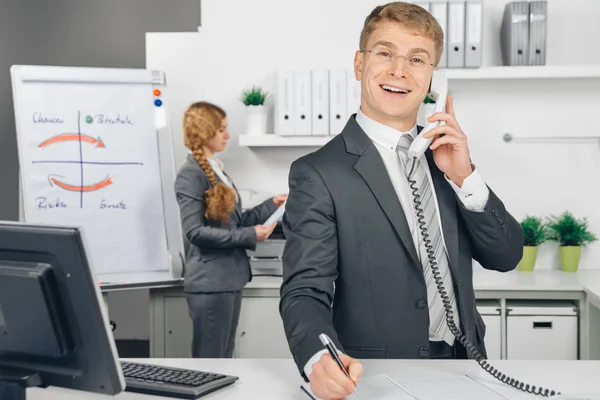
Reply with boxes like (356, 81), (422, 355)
(547, 211), (597, 272)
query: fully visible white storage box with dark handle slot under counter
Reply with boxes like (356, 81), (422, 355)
(506, 301), (579, 360)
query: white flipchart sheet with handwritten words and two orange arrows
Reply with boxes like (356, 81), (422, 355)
(18, 82), (169, 273)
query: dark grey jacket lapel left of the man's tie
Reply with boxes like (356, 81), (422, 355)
(342, 117), (421, 268)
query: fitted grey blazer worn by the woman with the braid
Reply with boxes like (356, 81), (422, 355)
(175, 154), (277, 293)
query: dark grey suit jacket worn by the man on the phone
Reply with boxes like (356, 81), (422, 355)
(280, 116), (523, 379)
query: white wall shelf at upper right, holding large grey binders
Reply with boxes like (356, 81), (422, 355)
(446, 65), (600, 80)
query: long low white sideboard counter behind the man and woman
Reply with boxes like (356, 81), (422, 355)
(144, 265), (600, 360)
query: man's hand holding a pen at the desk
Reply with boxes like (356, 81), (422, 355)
(308, 353), (363, 400)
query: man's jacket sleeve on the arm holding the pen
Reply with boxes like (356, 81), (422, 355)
(279, 159), (344, 380)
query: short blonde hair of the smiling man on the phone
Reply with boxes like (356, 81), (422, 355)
(359, 1), (444, 66)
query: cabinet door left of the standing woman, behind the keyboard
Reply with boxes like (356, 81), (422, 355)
(165, 297), (192, 358)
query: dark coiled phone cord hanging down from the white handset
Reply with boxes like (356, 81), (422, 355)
(408, 158), (560, 397)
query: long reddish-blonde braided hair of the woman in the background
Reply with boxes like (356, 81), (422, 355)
(183, 101), (236, 223)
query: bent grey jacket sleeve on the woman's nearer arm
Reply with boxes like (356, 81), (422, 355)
(175, 169), (256, 250)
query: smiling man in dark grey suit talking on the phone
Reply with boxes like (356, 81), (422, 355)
(280, 2), (523, 399)
